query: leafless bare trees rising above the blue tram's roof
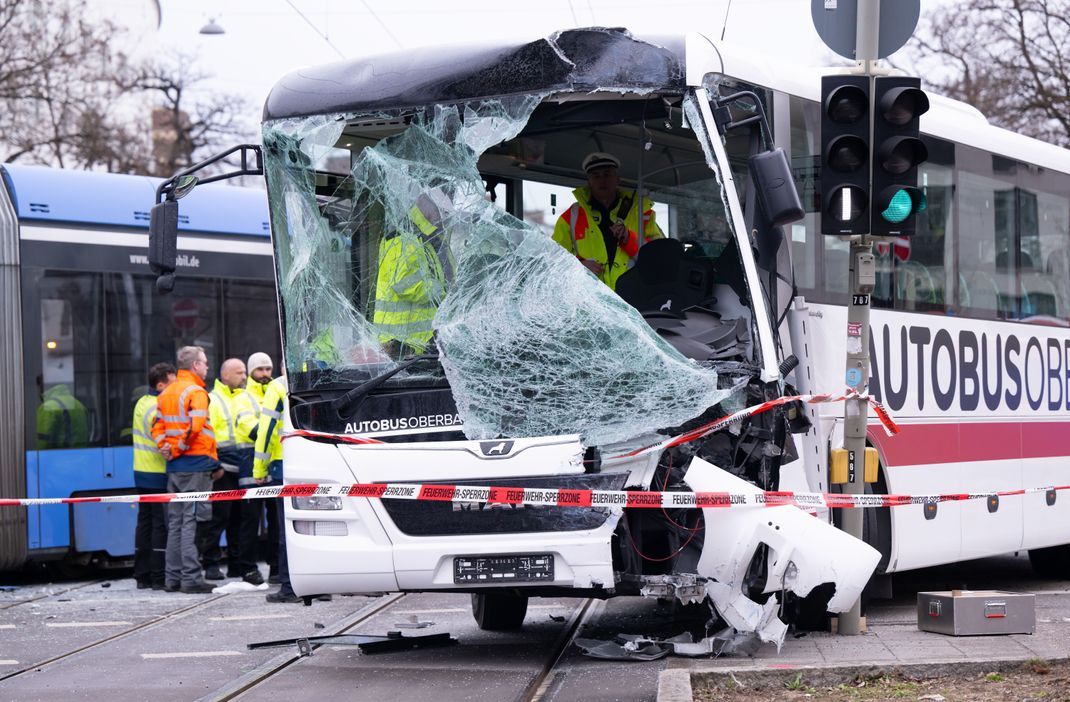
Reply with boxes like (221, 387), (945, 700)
(0, 0), (251, 176)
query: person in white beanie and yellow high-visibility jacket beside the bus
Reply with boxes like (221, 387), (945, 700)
(234, 351), (278, 585)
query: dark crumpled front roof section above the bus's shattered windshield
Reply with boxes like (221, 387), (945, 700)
(263, 28), (684, 121)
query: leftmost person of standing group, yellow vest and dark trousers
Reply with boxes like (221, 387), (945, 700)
(131, 363), (175, 590)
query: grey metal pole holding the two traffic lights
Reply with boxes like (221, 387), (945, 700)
(837, 0), (881, 636)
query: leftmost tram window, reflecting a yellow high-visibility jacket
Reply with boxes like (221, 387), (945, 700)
(35, 271), (107, 449)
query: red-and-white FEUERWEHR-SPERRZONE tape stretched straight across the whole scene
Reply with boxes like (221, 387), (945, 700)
(0, 483), (1070, 509)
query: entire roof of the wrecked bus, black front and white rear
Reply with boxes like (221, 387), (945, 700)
(263, 27), (1070, 178)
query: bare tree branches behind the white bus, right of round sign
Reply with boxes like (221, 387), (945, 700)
(908, 0), (1070, 147)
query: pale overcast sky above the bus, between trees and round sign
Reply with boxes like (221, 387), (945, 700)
(146, 0), (864, 113)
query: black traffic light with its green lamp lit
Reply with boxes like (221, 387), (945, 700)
(871, 76), (929, 236)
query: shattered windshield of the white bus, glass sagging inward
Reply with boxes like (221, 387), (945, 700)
(263, 94), (758, 445)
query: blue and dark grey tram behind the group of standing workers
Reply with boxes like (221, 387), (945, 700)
(0, 164), (279, 569)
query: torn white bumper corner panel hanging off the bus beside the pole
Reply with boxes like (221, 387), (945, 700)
(685, 457), (881, 607)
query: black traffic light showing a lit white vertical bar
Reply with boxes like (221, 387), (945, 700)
(821, 76), (870, 235)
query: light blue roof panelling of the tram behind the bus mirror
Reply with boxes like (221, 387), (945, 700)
(0, 164), (271, 236)
